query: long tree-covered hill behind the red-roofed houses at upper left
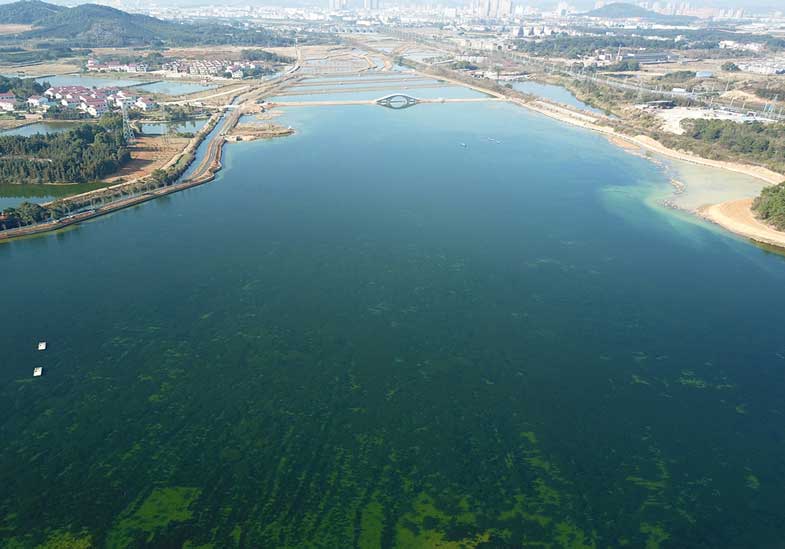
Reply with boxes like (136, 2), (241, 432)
(0, 0), (291, 48)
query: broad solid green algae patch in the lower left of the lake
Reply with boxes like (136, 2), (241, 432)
(107, 486), (201, 548)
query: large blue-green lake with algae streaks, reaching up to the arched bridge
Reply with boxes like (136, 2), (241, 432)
(0, 103), (785, 548)
